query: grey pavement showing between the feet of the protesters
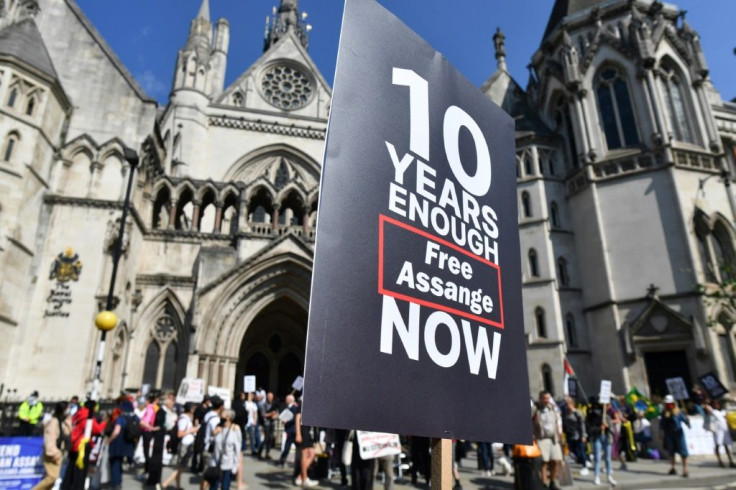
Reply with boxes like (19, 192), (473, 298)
(118, 452), (736, 490)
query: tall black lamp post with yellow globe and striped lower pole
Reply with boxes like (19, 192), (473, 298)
(80, 147), (138, 482)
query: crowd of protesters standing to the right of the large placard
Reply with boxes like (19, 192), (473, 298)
(532, 386), (736, 489)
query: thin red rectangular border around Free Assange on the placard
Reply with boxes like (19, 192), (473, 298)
(378, 214), (504, 330)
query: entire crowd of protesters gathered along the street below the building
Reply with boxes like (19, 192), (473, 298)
(7, 388), (736, 490)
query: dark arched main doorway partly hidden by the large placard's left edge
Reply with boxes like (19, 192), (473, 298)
(235, 297), (307, 397)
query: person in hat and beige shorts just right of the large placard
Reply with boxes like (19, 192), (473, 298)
(533, 391), (562, 490)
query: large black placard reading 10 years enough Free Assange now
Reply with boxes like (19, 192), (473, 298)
(303, 0), (531, 444)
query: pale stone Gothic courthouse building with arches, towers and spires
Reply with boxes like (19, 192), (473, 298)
(0, 0), (736, 397)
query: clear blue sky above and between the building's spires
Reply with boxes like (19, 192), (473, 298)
(77, 0), (736, 103)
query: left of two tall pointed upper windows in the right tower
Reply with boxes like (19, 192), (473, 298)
(596, 67), (639, 150)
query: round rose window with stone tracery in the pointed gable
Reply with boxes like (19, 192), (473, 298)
(261, 65), (313, 111)
